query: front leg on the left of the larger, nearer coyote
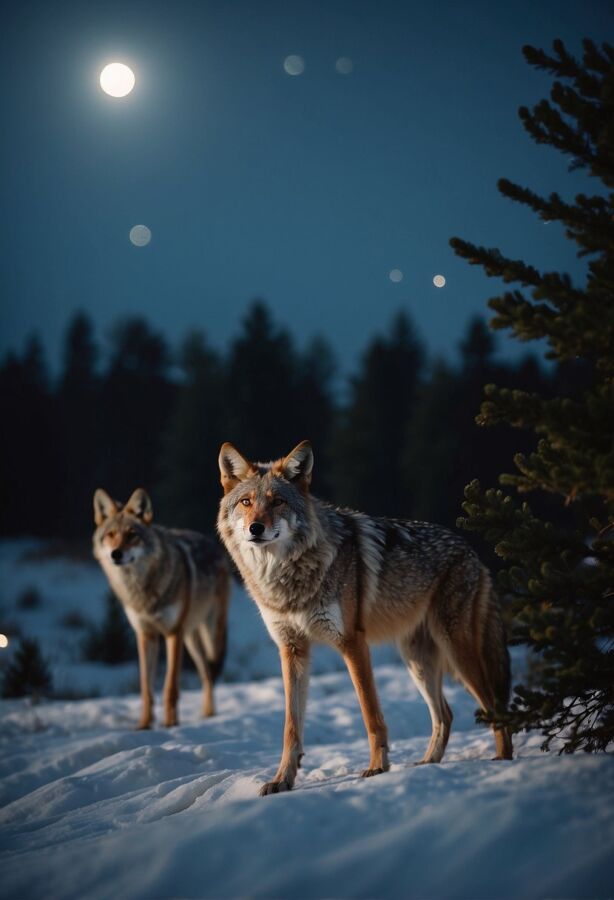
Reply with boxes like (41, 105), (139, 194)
(260, 641), (309, 797)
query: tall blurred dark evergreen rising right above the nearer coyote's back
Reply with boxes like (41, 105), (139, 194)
(333, 313), (424, 516)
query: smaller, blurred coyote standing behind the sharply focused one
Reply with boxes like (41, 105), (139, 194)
(93, 488), (230, 728)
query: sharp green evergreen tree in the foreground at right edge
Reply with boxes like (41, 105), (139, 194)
(451, 41), (614, 752)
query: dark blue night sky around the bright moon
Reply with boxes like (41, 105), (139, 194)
(0, 0), (614, 370)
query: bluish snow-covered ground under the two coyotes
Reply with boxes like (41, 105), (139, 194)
(0, 545), (614, 900)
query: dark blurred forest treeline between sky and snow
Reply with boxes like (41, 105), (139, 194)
(0, 302), (569, 537)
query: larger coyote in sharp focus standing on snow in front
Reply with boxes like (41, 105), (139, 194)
(218, 441), (512, 794)
